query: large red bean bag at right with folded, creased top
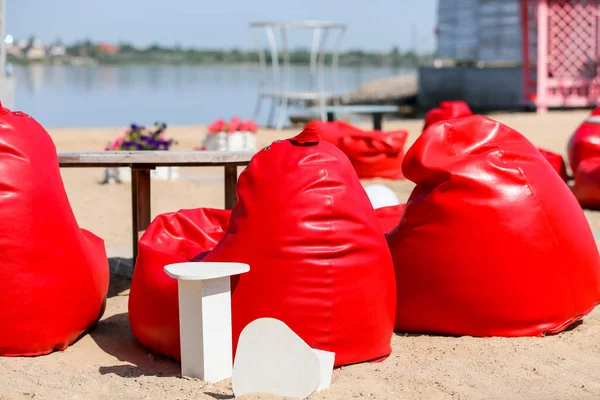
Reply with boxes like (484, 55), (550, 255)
(388, 116), (600, 336)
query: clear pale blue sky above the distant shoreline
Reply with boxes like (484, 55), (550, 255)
(6, 0), (437, 52)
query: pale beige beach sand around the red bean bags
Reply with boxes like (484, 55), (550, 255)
(0, 111), (600, 400)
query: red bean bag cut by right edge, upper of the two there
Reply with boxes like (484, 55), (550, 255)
(567, 107), (600, 174)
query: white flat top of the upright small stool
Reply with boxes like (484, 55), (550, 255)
(165, 262), (250, 281)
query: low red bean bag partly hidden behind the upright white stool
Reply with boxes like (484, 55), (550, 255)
(129, 208), (231, 360)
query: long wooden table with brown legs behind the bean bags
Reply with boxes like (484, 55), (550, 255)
(58, 151), (254, 263)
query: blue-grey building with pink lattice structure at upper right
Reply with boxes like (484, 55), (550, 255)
(419, 0), (600, 111)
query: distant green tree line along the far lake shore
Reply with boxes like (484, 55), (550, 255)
(9, 40), (433, 68)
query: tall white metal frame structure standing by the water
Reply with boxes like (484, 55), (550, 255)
(250, 21), (347, 129)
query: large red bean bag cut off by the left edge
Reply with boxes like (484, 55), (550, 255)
(0, 105), (109, 356)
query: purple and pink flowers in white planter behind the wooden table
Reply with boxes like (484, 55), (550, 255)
(103, 122), (179, 183)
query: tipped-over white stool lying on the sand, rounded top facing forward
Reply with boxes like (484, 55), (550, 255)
(231, 318), (335, 398)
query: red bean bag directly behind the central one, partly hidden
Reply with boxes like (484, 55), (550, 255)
(306, 121), (408, 179)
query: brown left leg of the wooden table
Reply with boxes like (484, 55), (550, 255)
(131, 168), (150, 266)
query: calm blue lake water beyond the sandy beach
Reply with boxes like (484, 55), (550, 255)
(13, 65), (413, 127)
